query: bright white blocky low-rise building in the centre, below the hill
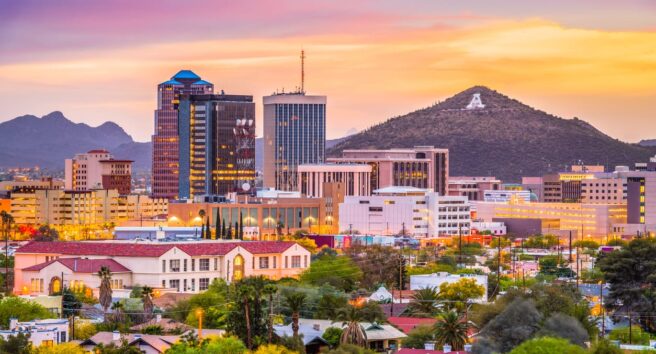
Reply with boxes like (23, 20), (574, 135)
(339, 187), (471, 237)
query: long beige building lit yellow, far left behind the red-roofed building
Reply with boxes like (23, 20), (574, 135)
(11, 189), (168, 236)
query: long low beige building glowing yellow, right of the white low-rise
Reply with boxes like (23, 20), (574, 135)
(473, 201), (627, 240)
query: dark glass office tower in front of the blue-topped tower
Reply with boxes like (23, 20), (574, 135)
(178, 93), (255, 198)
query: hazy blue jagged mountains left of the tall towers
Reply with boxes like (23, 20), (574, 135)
(0, 111), (152, 170)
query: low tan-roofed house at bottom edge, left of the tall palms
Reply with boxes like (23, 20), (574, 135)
(80, 331), (180, 354)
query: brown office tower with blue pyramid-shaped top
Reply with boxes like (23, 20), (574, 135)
(152, 70), (214, 199)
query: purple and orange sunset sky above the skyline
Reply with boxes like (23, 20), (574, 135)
(0, 0), (656, 142)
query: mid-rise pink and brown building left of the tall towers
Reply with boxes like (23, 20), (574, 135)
(64, 150), (133, 194)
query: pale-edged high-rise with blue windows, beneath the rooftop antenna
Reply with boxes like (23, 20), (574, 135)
(263, 90), (326, 191)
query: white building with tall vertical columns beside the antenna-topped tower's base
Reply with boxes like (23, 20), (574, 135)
(297, 164), (371, 198)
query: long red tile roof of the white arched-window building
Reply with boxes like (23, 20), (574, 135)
(16, 241), (301, 257)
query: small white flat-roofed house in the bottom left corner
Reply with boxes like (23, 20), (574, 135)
(0, 318), (69, 347)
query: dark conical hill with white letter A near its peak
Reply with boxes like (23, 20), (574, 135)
(328, 86), (656, 181)
